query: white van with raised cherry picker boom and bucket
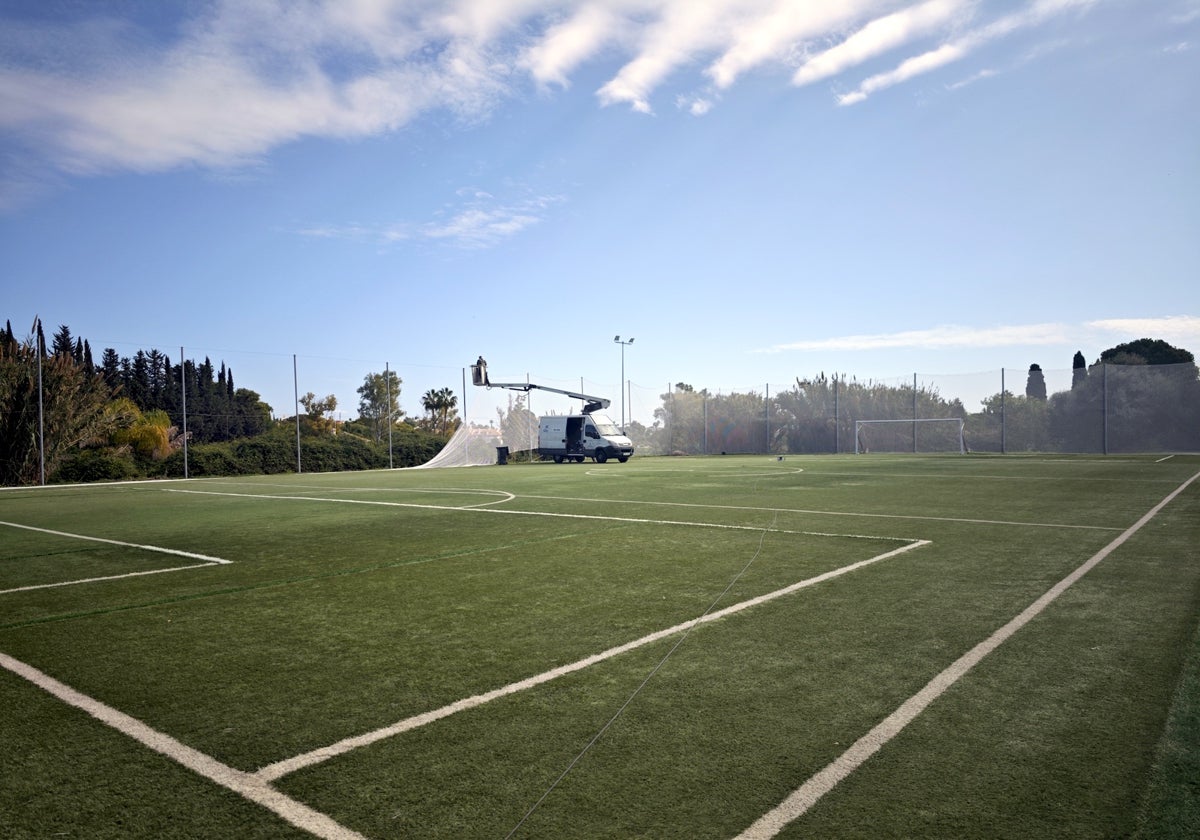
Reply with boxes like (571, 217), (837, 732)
(470, 356), (634, 463)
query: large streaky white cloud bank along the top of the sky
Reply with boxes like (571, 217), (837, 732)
(0, 0), (1118, 203)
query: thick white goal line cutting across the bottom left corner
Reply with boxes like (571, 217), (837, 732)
(0, 653), (365, 840)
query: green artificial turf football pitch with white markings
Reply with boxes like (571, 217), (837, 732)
(0, 455), (1200, 840)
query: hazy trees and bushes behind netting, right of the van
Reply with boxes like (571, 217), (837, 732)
(604, 338), (1200, 455)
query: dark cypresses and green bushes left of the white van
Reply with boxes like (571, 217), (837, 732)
(0, 320), (457, 485)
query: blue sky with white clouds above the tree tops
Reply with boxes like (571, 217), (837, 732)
(0, 0), (1200, 421)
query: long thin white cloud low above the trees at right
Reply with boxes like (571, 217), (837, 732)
(760, 316), (1200, 353)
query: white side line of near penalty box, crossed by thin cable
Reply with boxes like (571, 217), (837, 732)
(254, 542), (929, 782)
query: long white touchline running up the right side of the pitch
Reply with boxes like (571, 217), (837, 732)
(737, 473), (1200, 840)
